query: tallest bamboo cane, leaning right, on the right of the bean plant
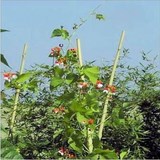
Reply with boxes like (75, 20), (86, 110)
(98, 31), (125, 140)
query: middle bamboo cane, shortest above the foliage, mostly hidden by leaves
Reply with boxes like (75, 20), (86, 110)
(77, 39), (93, 153)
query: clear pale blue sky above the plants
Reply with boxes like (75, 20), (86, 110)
(1, 0), (160, 71)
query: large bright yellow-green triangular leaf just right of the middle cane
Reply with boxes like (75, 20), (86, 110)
(83, 66), (99, 84)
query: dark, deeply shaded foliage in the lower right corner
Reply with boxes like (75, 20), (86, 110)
(140, 91), (160, 159)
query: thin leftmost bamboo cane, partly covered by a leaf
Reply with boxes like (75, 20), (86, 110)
(10, 44), (27, 131)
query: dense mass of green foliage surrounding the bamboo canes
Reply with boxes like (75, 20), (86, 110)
(2, 50), (160, 159)
